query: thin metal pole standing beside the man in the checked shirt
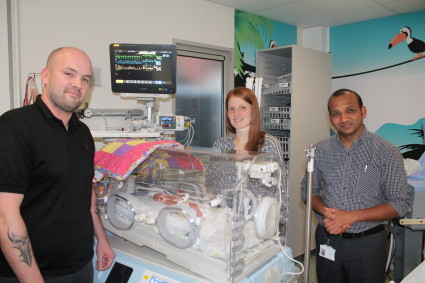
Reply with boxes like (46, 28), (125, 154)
(304, 145), (316, 283)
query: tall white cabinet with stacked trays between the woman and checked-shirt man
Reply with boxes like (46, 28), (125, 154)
(256, 45), (332, 256)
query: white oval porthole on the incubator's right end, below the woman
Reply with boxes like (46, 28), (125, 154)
(255, 197), (280, 239)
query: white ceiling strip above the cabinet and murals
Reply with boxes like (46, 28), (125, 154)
(205, 0), (425, 28)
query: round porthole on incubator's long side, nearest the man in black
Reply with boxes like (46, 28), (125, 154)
(106, 193), (140, 230)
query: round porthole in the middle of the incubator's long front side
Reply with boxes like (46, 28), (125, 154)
(157, 204), (198, 249)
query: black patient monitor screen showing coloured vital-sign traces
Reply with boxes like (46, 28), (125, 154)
(109, 43), (177, 94)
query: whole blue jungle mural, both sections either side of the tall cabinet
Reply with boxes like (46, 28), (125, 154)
(234, 10), (425, 159)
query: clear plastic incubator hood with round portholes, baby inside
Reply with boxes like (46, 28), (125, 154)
(97, 148), (288, 282)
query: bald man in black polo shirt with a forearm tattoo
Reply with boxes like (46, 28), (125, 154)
(0, 47), (114, 283)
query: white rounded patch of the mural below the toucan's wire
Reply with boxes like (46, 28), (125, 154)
(332, 67), (425, 135)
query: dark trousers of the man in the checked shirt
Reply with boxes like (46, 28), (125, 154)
(316, 224), (387, 283)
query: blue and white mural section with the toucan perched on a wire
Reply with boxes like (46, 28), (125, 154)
(330, 11), (425, 159)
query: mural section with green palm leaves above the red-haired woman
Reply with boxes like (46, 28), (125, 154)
(234, 10), (297, 86)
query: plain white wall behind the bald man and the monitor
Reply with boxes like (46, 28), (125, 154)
(14, 0), (234, 130)
